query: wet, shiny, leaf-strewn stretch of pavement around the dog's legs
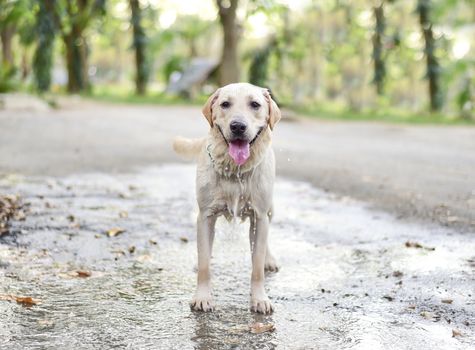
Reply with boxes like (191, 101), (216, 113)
(0, 165), (475, 349)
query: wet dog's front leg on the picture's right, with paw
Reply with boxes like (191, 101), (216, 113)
(249, 214), (273, 314)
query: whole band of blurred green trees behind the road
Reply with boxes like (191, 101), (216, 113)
(0, 0), (475, 119)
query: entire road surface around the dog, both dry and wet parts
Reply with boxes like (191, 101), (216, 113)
(0, 100), (475, 349)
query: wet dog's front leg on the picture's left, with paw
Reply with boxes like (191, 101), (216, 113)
(191, 213), (216, 311)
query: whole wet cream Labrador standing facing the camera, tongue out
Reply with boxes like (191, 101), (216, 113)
(173, 83), (281, 314)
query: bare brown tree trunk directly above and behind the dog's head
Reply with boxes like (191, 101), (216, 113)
(217, 0), (240, 85)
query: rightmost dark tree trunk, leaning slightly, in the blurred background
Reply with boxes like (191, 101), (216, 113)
(417, 0), (443, 111)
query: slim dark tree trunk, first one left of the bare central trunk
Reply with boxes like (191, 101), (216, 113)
(129, 0), (148, 95)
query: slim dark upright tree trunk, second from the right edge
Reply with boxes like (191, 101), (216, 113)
(373, 1), (386, 96)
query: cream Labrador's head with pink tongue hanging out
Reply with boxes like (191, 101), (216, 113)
(203, 83), (281, 165)
